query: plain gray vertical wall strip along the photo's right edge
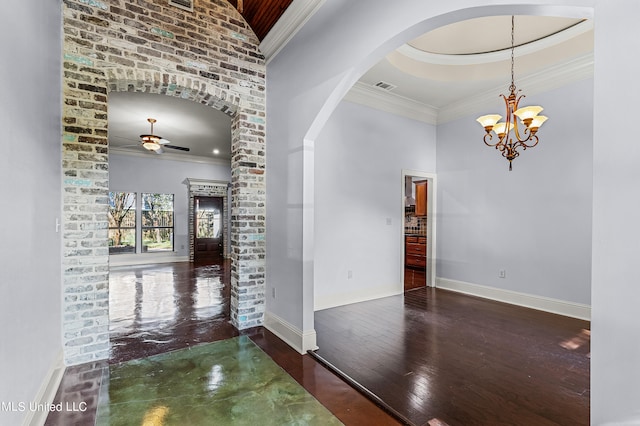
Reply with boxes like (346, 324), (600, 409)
(591, 0), (640, 425)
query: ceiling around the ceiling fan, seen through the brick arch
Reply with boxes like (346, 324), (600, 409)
(109, 92), (231, 161)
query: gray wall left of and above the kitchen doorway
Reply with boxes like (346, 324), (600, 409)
(314, 102), (436, 309)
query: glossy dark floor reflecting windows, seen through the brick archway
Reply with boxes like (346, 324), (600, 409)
(109, 260), (238, 362)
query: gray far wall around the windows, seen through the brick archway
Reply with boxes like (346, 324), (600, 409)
(109, 154), (231, 256)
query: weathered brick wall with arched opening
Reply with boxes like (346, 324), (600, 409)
(62, 0), (266, 365)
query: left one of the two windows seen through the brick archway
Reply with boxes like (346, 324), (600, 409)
(108, 192), (136, 254)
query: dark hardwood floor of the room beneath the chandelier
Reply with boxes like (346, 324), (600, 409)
(315, 287), (590, 426)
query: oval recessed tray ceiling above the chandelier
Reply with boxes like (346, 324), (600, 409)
(359, 16), (593, 113)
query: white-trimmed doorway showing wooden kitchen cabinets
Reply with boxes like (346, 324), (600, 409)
(400, 170), (436, 291)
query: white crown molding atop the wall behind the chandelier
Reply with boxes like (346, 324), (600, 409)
(438, 52), (593, 124)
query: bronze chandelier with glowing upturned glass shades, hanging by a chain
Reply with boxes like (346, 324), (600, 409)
(476, 16), (547, 171)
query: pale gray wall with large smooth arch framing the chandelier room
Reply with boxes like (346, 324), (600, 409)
(267, 0), (640, 425)
